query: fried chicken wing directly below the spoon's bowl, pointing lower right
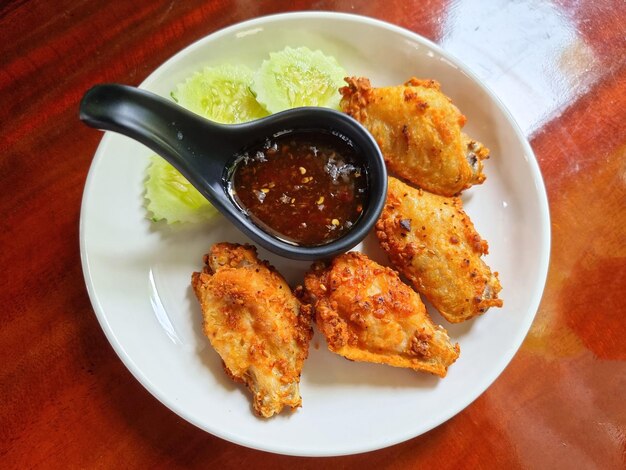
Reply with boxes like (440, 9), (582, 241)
(303, 252), (459, 377)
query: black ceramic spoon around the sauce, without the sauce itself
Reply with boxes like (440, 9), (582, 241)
(80, 84), (387, 260)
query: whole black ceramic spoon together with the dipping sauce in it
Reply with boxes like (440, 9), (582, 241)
(80, 84), (387, 260)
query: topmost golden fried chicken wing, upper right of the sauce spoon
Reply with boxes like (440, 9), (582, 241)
(339, 77), (489, 196)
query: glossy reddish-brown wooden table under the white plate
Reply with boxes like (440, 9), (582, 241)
(0, 0), (626, 469)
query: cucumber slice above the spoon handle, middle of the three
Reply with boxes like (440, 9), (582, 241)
(172, 64), (267, 124)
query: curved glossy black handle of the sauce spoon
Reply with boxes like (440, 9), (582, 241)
(80, 84), (241, 212)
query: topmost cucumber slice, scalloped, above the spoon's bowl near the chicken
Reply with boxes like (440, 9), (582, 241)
(251, 47), (346, 113)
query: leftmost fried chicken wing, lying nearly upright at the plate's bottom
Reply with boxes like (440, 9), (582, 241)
(191, 243), (312, 418)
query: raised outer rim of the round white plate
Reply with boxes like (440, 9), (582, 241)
(79, 11), (551, 457)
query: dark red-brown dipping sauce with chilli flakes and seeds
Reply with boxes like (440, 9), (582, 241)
(230, 131), (367, 246)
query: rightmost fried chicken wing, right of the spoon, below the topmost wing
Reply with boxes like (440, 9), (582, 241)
(376, 178), (502, 323)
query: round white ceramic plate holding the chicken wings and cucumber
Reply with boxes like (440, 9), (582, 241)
(81, 13), (550, 456)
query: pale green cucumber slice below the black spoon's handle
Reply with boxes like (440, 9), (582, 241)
(145, 155), (218, 224)
